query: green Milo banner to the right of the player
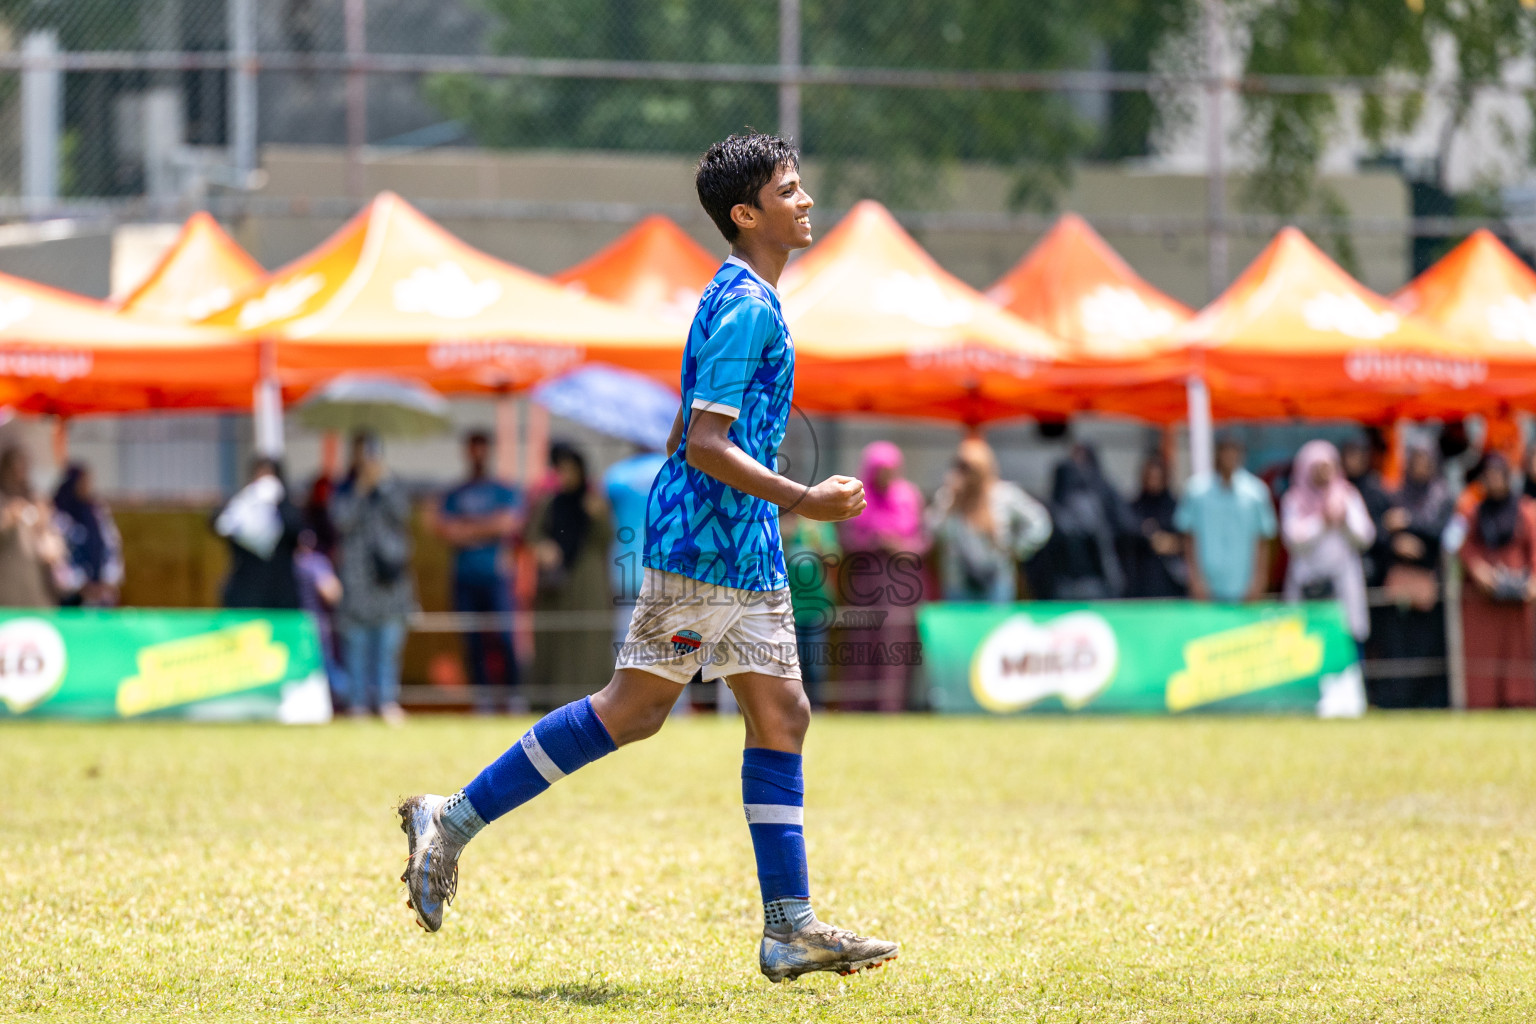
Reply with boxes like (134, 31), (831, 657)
(917, 600), (1366, 717)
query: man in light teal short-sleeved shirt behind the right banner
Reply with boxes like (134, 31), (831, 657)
(1174, 438), (1275, 602)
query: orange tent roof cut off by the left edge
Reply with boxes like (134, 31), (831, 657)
(0, 275), (257, 416)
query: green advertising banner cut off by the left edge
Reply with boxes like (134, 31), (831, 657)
(0, 608), (330, 723)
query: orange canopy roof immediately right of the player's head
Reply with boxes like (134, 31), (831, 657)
(782, 200), (1074, 424)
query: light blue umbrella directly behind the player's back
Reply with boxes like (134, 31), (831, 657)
(530, 364), (682, 451)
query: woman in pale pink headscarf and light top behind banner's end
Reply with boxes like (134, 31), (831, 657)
(1279, 441), (1376, 643)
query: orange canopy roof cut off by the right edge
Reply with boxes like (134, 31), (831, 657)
(1392, 227), (1536, 404)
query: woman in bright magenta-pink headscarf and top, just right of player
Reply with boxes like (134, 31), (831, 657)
(839, 441), (928, 711)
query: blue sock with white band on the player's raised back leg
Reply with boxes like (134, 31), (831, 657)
(444, 697), (617, 841)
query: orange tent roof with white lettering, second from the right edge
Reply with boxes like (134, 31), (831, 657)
(1169, 227), (1488, 419)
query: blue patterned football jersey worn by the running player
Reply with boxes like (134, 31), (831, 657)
(645, 256), (794, 590)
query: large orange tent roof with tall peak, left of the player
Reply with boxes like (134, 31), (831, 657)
(206, 192), (684, 396)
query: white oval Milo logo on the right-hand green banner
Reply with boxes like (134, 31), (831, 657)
(971, 611), (1120, 714)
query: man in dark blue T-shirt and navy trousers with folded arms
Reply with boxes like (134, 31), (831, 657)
(432, 430), (527, 712)
